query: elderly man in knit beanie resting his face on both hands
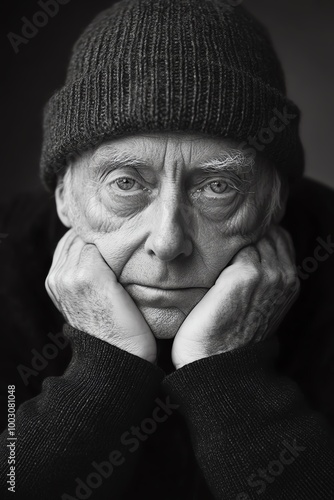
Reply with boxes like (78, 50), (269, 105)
(1, 0), (334, 500)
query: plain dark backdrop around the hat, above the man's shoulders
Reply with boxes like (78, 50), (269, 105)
(0, 0), (334, 198)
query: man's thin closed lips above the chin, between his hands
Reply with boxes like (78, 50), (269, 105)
(123, 283), (208, 307)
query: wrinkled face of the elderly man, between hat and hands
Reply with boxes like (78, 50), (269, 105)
(56, 133), (280, 338)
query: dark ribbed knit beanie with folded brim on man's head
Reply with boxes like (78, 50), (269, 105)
(41, 0), (304, 190)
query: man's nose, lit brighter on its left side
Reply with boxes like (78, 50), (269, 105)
(145, 199), (193, 262)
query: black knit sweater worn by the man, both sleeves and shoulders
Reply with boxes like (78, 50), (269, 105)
(0, 180), (334, 500)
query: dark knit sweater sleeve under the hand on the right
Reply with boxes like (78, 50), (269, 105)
(163, 338), (334, 500)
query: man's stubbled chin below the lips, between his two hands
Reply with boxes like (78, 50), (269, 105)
(139, 307), (186, 339)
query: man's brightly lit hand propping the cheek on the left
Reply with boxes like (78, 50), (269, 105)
(45, 229), (156, 363)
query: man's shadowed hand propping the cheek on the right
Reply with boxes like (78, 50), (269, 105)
(172, 226), (299, 368)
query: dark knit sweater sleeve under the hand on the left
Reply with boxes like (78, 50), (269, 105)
(0, 325), (164, 500)
